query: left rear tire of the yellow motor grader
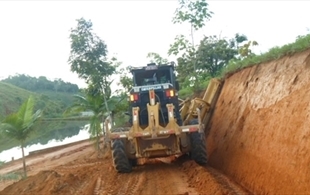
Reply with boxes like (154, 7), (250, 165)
(112, 139), (132, 173)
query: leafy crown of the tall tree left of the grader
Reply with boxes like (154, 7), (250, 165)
(69, 18), (117, 99)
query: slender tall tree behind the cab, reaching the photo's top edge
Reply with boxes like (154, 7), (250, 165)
(168, 0), (213, 87)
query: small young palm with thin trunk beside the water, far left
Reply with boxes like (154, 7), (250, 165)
(0, 96), (41, 177)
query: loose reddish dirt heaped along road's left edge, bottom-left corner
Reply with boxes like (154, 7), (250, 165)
(0, 155), (111, 195)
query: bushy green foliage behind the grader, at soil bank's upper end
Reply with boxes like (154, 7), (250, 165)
(168, 34), (251, 89)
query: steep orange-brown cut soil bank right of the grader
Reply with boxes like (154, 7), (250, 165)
(207, 50), (310, 194)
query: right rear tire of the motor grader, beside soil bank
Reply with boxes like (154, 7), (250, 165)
(189, 119), (208, 165)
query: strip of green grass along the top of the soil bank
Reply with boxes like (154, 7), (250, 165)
(220, 34), (310, 78)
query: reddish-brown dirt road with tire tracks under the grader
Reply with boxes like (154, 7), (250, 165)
(0, 141), (250, 195)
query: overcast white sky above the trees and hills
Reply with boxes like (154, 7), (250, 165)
(0, 0), (310, 87)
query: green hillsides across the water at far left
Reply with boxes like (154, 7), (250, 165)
(0, 75), (79, 120)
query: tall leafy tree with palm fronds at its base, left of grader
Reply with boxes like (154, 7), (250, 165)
(66, 18), (119, 152)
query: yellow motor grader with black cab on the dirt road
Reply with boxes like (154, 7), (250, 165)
(106, 63), (220, 173)
